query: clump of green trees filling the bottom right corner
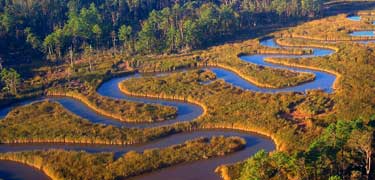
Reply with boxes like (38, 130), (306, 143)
(237, 120), (374, 180)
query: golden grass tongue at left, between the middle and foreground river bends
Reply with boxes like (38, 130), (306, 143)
(0, 101), (192, 145)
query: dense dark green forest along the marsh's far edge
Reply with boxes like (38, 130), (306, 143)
(0, 0), (322, 64)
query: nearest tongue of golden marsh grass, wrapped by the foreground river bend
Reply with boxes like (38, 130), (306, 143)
(0, 136), (246, 180)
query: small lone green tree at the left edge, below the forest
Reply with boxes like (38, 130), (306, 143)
(0, 68), (21, 95)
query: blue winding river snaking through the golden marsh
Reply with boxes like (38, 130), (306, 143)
(0, 39), (336, 179)
